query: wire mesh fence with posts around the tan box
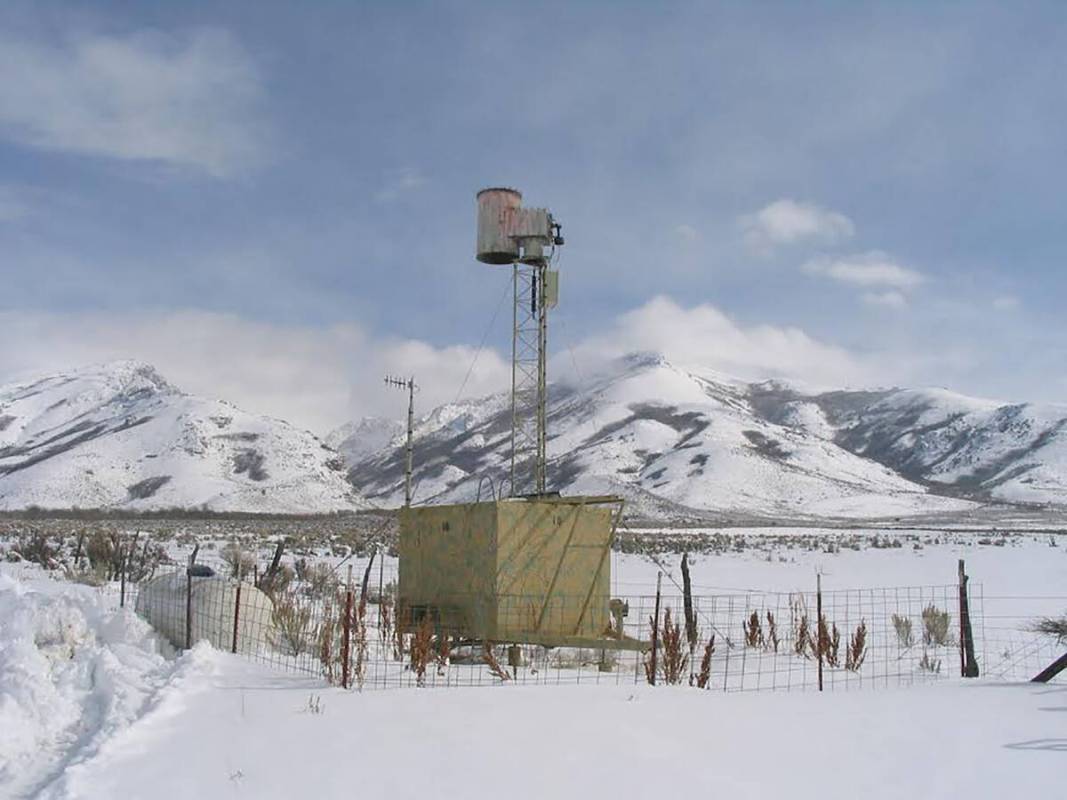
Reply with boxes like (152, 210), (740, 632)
(106, 566), (1067, 692)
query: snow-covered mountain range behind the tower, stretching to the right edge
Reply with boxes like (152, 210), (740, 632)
(349, 354), (1067, 517)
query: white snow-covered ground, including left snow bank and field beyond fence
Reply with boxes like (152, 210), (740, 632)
(0, 530), (1067, 800)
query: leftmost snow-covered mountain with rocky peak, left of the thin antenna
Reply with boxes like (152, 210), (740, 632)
(0, 362), (366, 513)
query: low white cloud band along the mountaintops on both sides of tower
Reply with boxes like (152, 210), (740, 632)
(0, 297), (960, 434)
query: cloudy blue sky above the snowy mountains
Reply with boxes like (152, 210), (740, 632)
(0, 0), (1067, 433)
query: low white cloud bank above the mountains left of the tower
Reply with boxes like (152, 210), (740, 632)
(0, 311), (511, 434)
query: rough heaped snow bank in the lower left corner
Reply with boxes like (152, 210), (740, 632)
(0, 564), (173, 797)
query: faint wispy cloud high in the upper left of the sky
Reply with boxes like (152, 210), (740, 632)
(0, 29), (266, 176)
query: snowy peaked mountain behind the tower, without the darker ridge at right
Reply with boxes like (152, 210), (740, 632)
(349, 354), (971, 517)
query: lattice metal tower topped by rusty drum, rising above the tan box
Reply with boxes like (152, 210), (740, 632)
(477, 189), (563, 495)
